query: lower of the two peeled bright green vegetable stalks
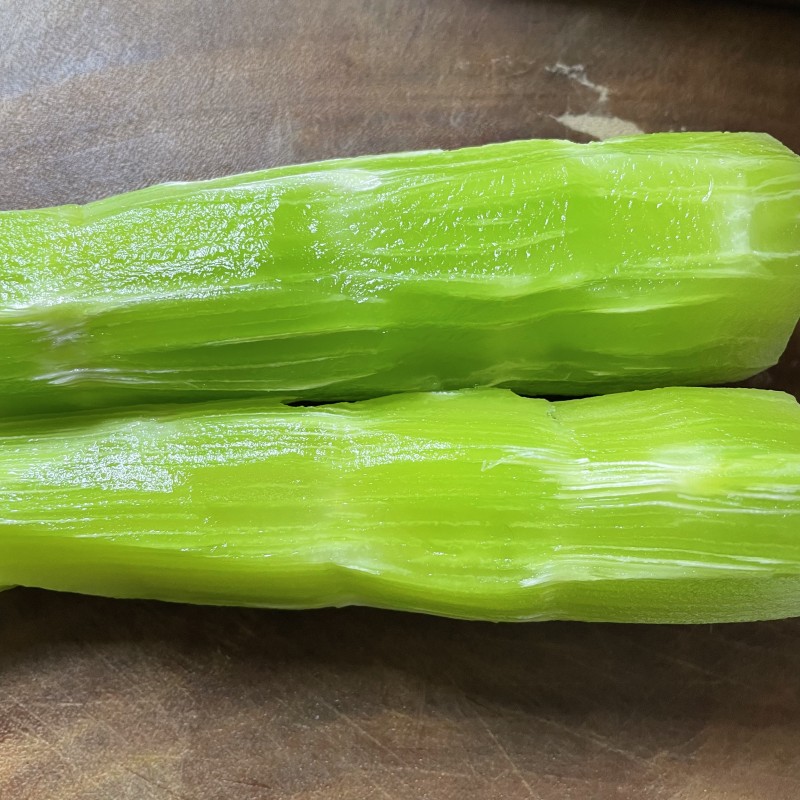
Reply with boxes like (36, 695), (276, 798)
(0, 388), (800, 622)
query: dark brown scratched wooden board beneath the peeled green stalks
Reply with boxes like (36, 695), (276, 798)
(0, 0), (800, 800)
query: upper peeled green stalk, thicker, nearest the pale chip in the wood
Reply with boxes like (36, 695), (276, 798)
(0, 133), (800, 414)
